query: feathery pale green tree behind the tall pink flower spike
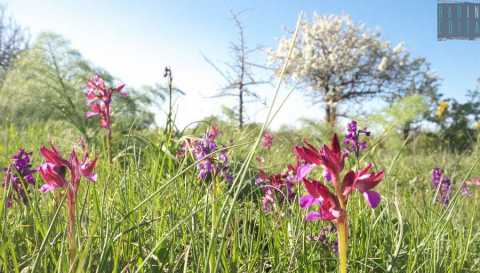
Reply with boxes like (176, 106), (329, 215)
(0, 33), (94, 135)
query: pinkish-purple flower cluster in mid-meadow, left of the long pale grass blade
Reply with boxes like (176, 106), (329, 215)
(177, 126), (233, 182)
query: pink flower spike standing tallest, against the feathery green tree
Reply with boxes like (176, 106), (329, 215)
(85, 75), (127, 131)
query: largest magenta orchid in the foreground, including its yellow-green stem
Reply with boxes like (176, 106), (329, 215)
(294, 120), (384, 273)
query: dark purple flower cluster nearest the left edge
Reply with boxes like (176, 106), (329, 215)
(3, 149), (36, 207)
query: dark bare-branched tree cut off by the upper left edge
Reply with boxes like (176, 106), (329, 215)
(0, 5), (29, 84)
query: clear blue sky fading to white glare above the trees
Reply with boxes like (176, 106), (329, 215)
(0, 0), (480, 126)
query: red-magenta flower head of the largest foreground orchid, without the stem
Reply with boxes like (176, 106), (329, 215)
(294, 135), (384, 221)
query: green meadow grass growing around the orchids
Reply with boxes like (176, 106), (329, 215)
(0, 121), (480, 273)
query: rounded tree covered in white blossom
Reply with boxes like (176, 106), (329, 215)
(268, 14), (436, 125)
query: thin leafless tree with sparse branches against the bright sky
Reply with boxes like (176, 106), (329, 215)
(205, 12), (268, 128)
